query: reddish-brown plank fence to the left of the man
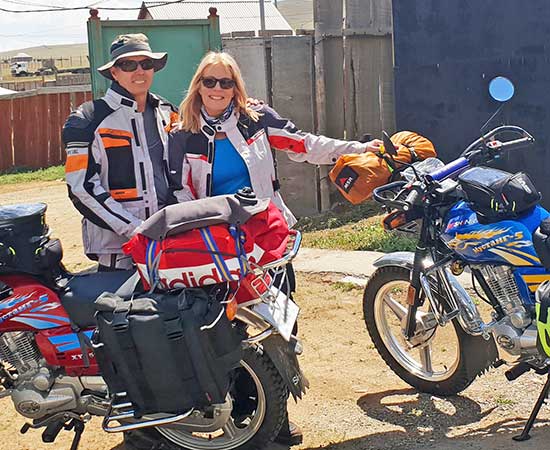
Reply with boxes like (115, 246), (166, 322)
(0, 86), (92, 171)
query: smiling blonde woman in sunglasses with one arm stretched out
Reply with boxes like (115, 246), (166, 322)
(168, 52), (381, 445)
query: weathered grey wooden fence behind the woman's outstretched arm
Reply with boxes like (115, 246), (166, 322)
(223, 0), (396, 215)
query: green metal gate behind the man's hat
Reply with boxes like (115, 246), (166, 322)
(88, 16), (222, 105)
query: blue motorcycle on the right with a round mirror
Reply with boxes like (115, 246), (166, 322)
(363, 77), (550, 440)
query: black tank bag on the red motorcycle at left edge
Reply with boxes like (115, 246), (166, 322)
(0, 203), (62, 275)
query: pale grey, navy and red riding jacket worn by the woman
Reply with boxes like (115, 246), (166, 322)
(168, 105), (366, 226)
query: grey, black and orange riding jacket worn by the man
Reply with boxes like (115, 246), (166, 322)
(62, 82), (177, 257)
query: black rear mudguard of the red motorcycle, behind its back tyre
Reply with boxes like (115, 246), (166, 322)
(262, 334), (309, 401)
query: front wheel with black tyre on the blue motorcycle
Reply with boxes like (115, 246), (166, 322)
(363, 266), (496, 396)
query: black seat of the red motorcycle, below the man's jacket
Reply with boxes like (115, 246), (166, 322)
(60, 270), (135, 328)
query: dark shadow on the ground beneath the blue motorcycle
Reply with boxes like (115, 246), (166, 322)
(310, 389), (550, 450)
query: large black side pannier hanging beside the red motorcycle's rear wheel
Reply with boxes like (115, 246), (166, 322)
(92, 289), (242, 417)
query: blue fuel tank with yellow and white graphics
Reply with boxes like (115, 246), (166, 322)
(441, 202), (550, 267)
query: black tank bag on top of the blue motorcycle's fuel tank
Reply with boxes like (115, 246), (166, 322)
(458, 167), (541, 220)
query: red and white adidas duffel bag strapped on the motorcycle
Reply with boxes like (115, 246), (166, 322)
(123, 190), (289, 303)
